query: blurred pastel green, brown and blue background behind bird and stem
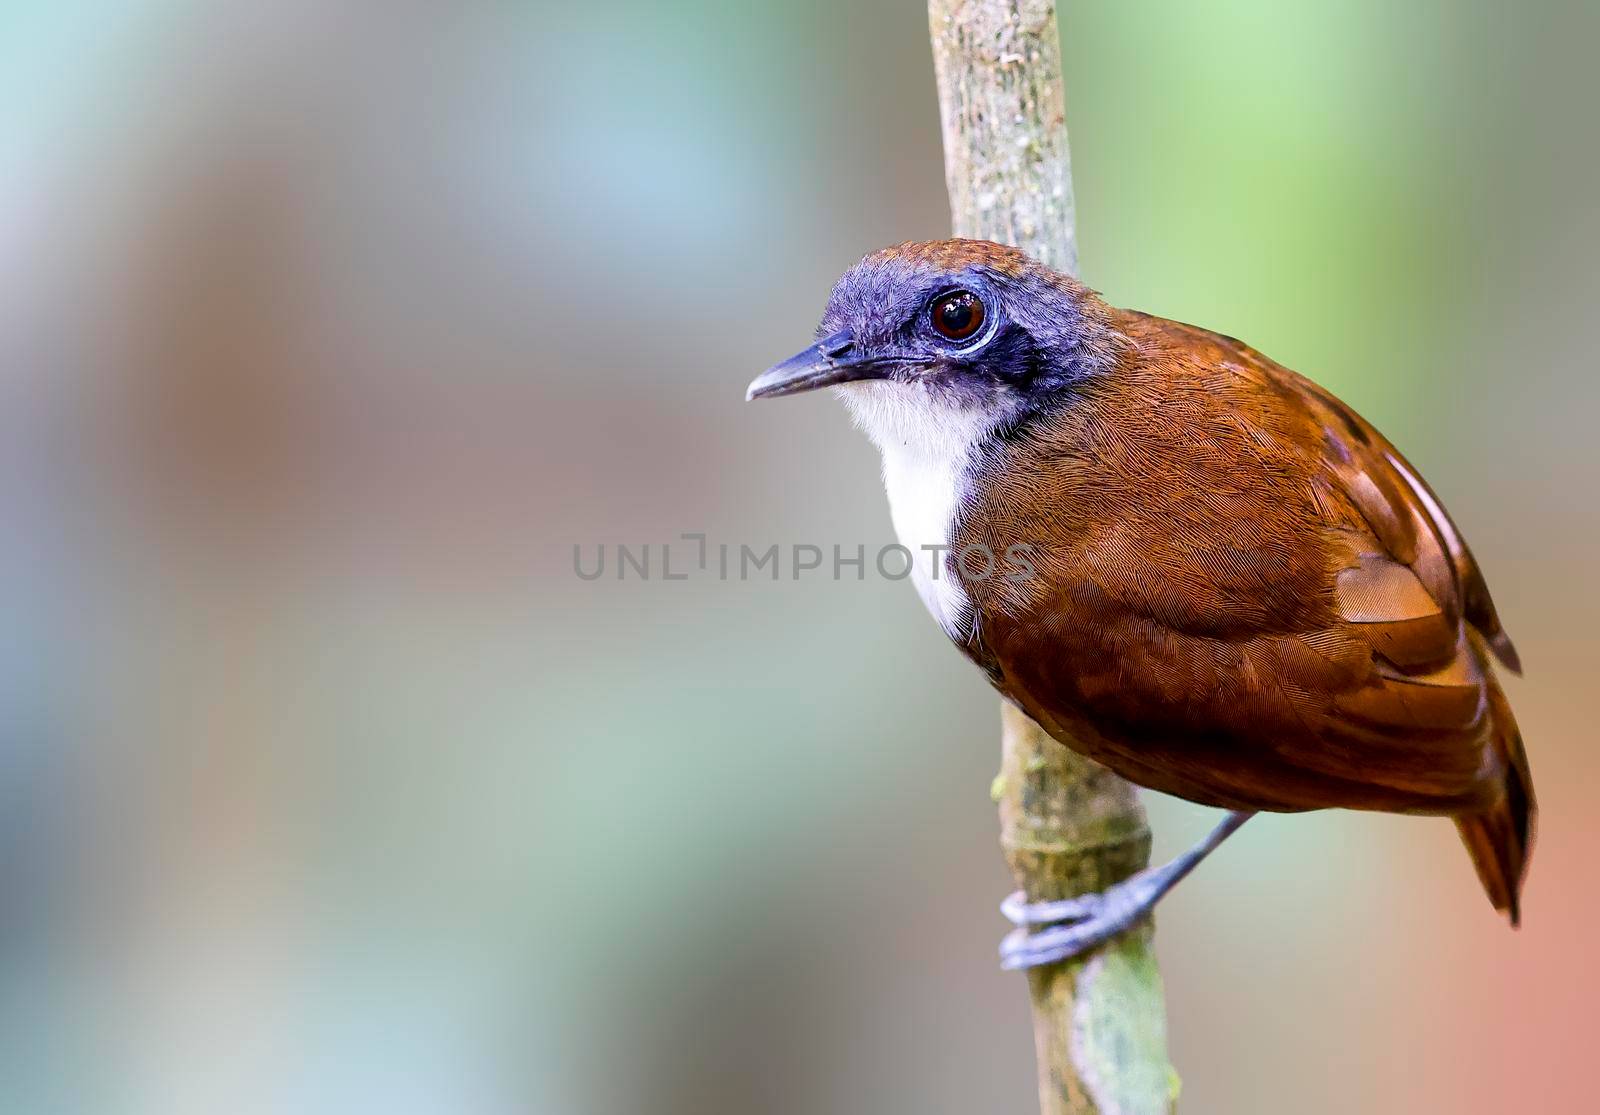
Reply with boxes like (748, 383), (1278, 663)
(0, 0), (1600, 1115)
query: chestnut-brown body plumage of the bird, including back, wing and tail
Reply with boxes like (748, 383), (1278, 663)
(954, 291), (1534, 923)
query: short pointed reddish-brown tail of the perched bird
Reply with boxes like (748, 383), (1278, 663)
(1456, 651), (1538, 926)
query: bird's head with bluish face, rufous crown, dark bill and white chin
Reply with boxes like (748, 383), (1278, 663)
(749, 240), (1120, 448)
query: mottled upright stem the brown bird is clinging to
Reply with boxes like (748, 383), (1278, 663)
(928, 0), (1178, 1115)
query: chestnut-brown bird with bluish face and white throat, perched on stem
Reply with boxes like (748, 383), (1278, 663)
(747, 240), (1536, 968)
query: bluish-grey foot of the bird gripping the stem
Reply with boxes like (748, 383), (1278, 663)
(1000, 869), (1166, 971)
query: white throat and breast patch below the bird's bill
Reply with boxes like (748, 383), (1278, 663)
(838, 381), (997, 641)
